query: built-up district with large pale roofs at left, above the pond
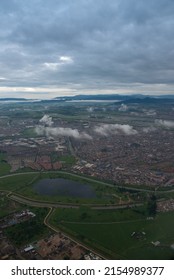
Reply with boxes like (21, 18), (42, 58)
(0, 138), (66, 172)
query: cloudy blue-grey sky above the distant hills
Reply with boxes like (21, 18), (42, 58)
(0, 0), (174, 99)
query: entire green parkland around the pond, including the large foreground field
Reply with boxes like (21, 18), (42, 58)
(0, 172), (174, 259)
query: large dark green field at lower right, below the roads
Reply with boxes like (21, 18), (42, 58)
(50, 208), (174, 259)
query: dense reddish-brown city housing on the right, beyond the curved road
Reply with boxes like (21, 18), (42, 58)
(73, 131), (174, 186)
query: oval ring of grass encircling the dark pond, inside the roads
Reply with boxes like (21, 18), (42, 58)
(0, 172), (127, 204)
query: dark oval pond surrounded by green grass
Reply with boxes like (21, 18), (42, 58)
(33, 178), (96, 198)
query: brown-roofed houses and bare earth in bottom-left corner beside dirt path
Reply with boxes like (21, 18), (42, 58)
(0, 221), (102, 260)
